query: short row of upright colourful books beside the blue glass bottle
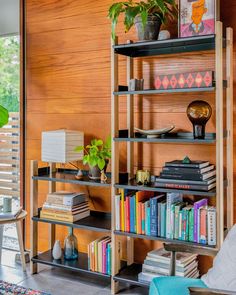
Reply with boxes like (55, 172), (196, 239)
(88, 237), (111, 275)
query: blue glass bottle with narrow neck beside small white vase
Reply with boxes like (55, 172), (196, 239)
(64, 227), (78, 260)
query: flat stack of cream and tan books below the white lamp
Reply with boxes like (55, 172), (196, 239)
(40, 191), (90, 223)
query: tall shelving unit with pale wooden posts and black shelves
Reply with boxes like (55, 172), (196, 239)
(111, 21), (233, 293)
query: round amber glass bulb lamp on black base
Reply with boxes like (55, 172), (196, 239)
(187, 100), (212, 139)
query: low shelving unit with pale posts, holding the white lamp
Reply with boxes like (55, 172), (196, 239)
(30, 161), (111, 279)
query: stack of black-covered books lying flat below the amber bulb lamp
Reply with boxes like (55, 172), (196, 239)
(155, 160), (216, 191)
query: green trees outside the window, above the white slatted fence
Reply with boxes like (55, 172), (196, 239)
(0, 36), (20, 112)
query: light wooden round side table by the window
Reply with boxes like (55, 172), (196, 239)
(0, 210), (27, 271)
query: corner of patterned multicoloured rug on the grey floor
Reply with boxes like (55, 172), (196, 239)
(0, 281), (50, 295)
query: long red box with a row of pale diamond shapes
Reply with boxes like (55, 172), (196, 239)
(155, 71), (214, 89)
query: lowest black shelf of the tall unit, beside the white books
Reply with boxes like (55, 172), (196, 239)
(113, 263), (149, 288)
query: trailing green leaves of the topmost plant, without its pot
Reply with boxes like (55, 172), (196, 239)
(108, 0), (177, 40)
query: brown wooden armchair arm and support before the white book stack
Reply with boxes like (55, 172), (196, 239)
(164, 243), (217, 276)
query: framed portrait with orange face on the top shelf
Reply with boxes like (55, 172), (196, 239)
(179, 0), (217, 38)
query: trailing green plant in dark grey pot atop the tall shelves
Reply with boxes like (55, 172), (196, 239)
(108, 0), (177, 40)
